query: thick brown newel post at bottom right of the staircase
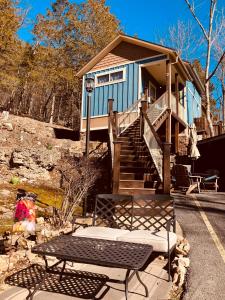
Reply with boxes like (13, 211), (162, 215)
(163, 143), (171, 194)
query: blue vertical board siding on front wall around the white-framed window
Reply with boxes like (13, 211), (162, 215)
(82, 55), (166, 117)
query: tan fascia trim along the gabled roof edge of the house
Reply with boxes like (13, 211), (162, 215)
(77, 34), (190, 77)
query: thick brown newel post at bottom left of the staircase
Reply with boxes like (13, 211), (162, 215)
(112, 141), (121, 194)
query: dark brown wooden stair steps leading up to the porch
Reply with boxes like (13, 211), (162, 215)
(117, 118), (157, 195)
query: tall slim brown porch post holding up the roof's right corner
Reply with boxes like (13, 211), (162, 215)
(166, 60), (171, 143)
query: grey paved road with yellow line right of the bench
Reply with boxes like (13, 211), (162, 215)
(175, 193), (225, 300)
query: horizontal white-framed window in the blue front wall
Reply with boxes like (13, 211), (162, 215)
(95, 68), (126, 86)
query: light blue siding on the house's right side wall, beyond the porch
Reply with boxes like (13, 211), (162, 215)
(186, 81), (202, 125)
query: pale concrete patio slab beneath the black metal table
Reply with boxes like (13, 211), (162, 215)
(0, 258), (171, 300)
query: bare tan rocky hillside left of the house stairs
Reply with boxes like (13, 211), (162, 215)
(0, 112), (106, 187)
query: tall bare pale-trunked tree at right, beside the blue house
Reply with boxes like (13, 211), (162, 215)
(185, 0), (224, 136)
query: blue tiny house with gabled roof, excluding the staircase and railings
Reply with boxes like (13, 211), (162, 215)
(78, 35), (201, 131)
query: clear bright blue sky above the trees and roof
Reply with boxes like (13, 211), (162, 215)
(19, 0), (225, 42)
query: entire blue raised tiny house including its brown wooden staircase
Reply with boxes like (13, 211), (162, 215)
(77, 35), (206, 194)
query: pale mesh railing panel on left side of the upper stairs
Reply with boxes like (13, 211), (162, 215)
(118, 99), (141, 135)
